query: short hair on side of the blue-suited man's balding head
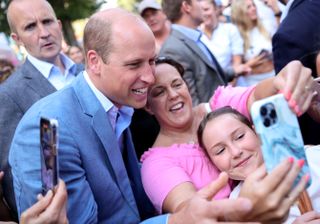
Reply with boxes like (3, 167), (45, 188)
(83, 13), (112, 63)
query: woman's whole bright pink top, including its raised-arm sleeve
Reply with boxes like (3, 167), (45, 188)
(141, 86), (254, 213)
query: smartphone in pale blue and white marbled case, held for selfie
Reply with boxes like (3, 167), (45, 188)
(250, 94), (311, 186)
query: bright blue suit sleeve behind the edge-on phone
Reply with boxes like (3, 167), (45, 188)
(9, 110), (98, 223)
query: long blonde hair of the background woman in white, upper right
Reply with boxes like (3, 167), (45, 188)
(231, 0), (271, 51)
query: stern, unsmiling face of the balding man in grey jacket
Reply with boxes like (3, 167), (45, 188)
(8, 0), (62, 63)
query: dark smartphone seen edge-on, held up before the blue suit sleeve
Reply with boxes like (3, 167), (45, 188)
(40, 117), (59, 195)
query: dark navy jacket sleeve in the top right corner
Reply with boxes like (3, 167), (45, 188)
(272, 0), (320, 73)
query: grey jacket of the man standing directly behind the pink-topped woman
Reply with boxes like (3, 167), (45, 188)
(159, 29), (227, 106)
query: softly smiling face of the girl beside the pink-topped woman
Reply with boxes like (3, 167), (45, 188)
(202, 113), (263, 180)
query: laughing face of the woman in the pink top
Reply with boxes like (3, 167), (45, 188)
(147, 63), (192, 129)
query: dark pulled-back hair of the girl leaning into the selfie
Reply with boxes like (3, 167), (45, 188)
(197, 106), (254, 152)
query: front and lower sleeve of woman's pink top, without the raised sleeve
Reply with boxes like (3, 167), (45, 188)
(141, 144), (231, 213)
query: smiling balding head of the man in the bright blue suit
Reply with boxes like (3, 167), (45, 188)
(85, 9), (155, 108)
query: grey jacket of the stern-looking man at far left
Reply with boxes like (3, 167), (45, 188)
(0, 60), (83, 217)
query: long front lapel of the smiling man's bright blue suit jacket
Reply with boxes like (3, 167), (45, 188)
(73, 74), (139, 216)
